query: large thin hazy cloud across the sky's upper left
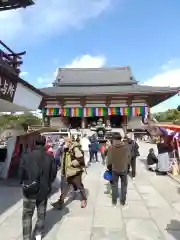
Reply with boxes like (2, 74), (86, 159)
(0, 0), (113, 40)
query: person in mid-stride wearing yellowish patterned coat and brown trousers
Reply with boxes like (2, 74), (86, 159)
(52, 139), (87, 210)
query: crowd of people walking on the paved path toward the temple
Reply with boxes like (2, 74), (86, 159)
(17, 133), (139, 240)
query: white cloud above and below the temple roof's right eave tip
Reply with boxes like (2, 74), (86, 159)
(144, 62), (180, 112)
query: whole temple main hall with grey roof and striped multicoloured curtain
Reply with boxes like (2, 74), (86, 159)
(40, 67), (179, 128)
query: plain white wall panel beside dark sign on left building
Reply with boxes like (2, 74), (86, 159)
(13, 83), (42, 110)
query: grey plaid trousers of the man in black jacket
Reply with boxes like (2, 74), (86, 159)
(22, 198), (47, 240)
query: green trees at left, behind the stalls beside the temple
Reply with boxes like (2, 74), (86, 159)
(0, 113), (42, 130)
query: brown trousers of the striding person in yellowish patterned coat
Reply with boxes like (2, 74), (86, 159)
(60, 173), (86, 202)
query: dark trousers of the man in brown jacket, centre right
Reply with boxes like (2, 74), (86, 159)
(111, 171), (128, 203)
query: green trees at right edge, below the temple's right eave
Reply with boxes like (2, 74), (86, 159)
(152, 109), (180, 124)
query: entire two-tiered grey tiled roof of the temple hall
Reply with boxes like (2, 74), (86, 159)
(41, 67), (179, 106)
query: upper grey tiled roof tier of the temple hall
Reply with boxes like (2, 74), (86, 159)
(53, 66), (137, 86)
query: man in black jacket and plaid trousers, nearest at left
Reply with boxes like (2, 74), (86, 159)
(19, 137), (57, 240)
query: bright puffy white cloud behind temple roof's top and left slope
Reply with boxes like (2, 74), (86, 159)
(37, 54), (106, 87)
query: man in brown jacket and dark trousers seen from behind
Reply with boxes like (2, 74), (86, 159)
(107, 133), (131, 205)
